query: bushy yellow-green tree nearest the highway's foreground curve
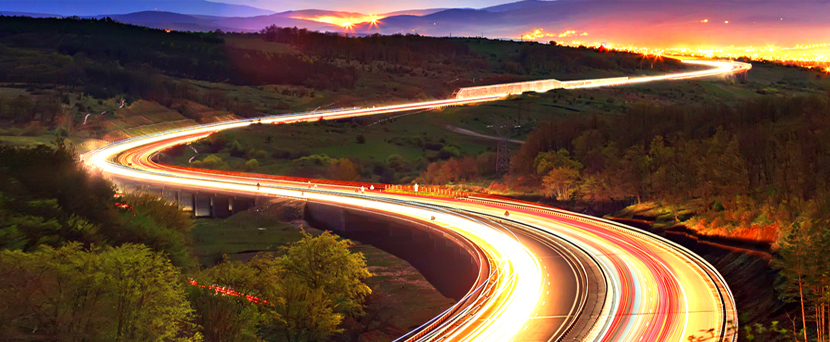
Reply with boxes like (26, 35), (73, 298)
(198, 232), (371, 341)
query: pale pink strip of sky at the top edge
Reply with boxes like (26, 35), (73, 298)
(214, 0), (508, 14)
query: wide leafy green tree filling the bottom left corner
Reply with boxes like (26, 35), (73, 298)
(0, 244), (201, 341)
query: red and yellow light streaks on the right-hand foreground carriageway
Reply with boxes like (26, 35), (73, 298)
(458, 198), (737, 341)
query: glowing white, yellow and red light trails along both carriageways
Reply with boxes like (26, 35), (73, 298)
(88, 61), (751, 341)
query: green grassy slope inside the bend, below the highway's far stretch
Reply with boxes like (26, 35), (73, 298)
(164, 64), (830, 181)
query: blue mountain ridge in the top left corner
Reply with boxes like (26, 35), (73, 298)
(0, 0), (274, 17)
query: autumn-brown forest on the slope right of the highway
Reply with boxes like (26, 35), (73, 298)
(420, 92), (830, 341)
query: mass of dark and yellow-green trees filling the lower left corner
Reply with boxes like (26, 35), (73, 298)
(0, 141), (371, 341)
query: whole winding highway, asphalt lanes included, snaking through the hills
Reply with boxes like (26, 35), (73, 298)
(82, 61), (750, 341)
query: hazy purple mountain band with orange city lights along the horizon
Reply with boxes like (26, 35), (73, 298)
(0, 0), (830, 47)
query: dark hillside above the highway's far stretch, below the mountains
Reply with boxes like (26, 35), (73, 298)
(0, 17), (684, 150)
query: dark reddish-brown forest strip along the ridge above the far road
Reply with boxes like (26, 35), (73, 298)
(260, 26), (683, 79)
